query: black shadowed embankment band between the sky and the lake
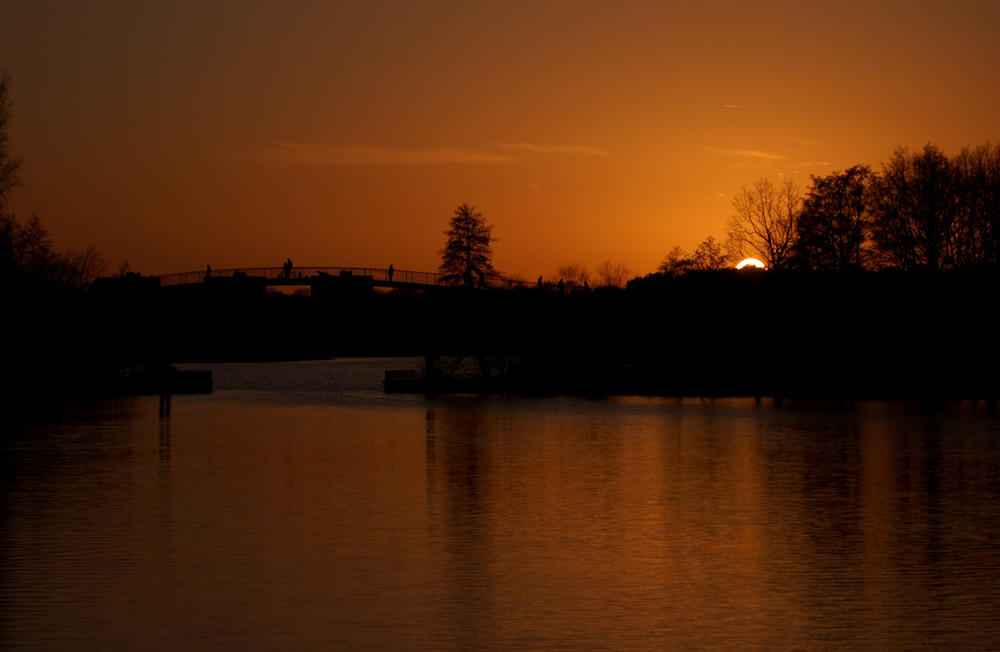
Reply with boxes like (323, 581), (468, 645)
(8, 271), (1000, 400)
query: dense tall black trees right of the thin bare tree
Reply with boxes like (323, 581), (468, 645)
(790, 142), (1000, 271)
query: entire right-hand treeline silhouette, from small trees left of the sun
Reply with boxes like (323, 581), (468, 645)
(660, 142), (1000, 274)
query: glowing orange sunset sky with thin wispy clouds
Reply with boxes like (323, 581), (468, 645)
(0, 0), (1000, 279)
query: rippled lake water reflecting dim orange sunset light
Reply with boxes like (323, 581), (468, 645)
(0, 360), (1000, 650)
